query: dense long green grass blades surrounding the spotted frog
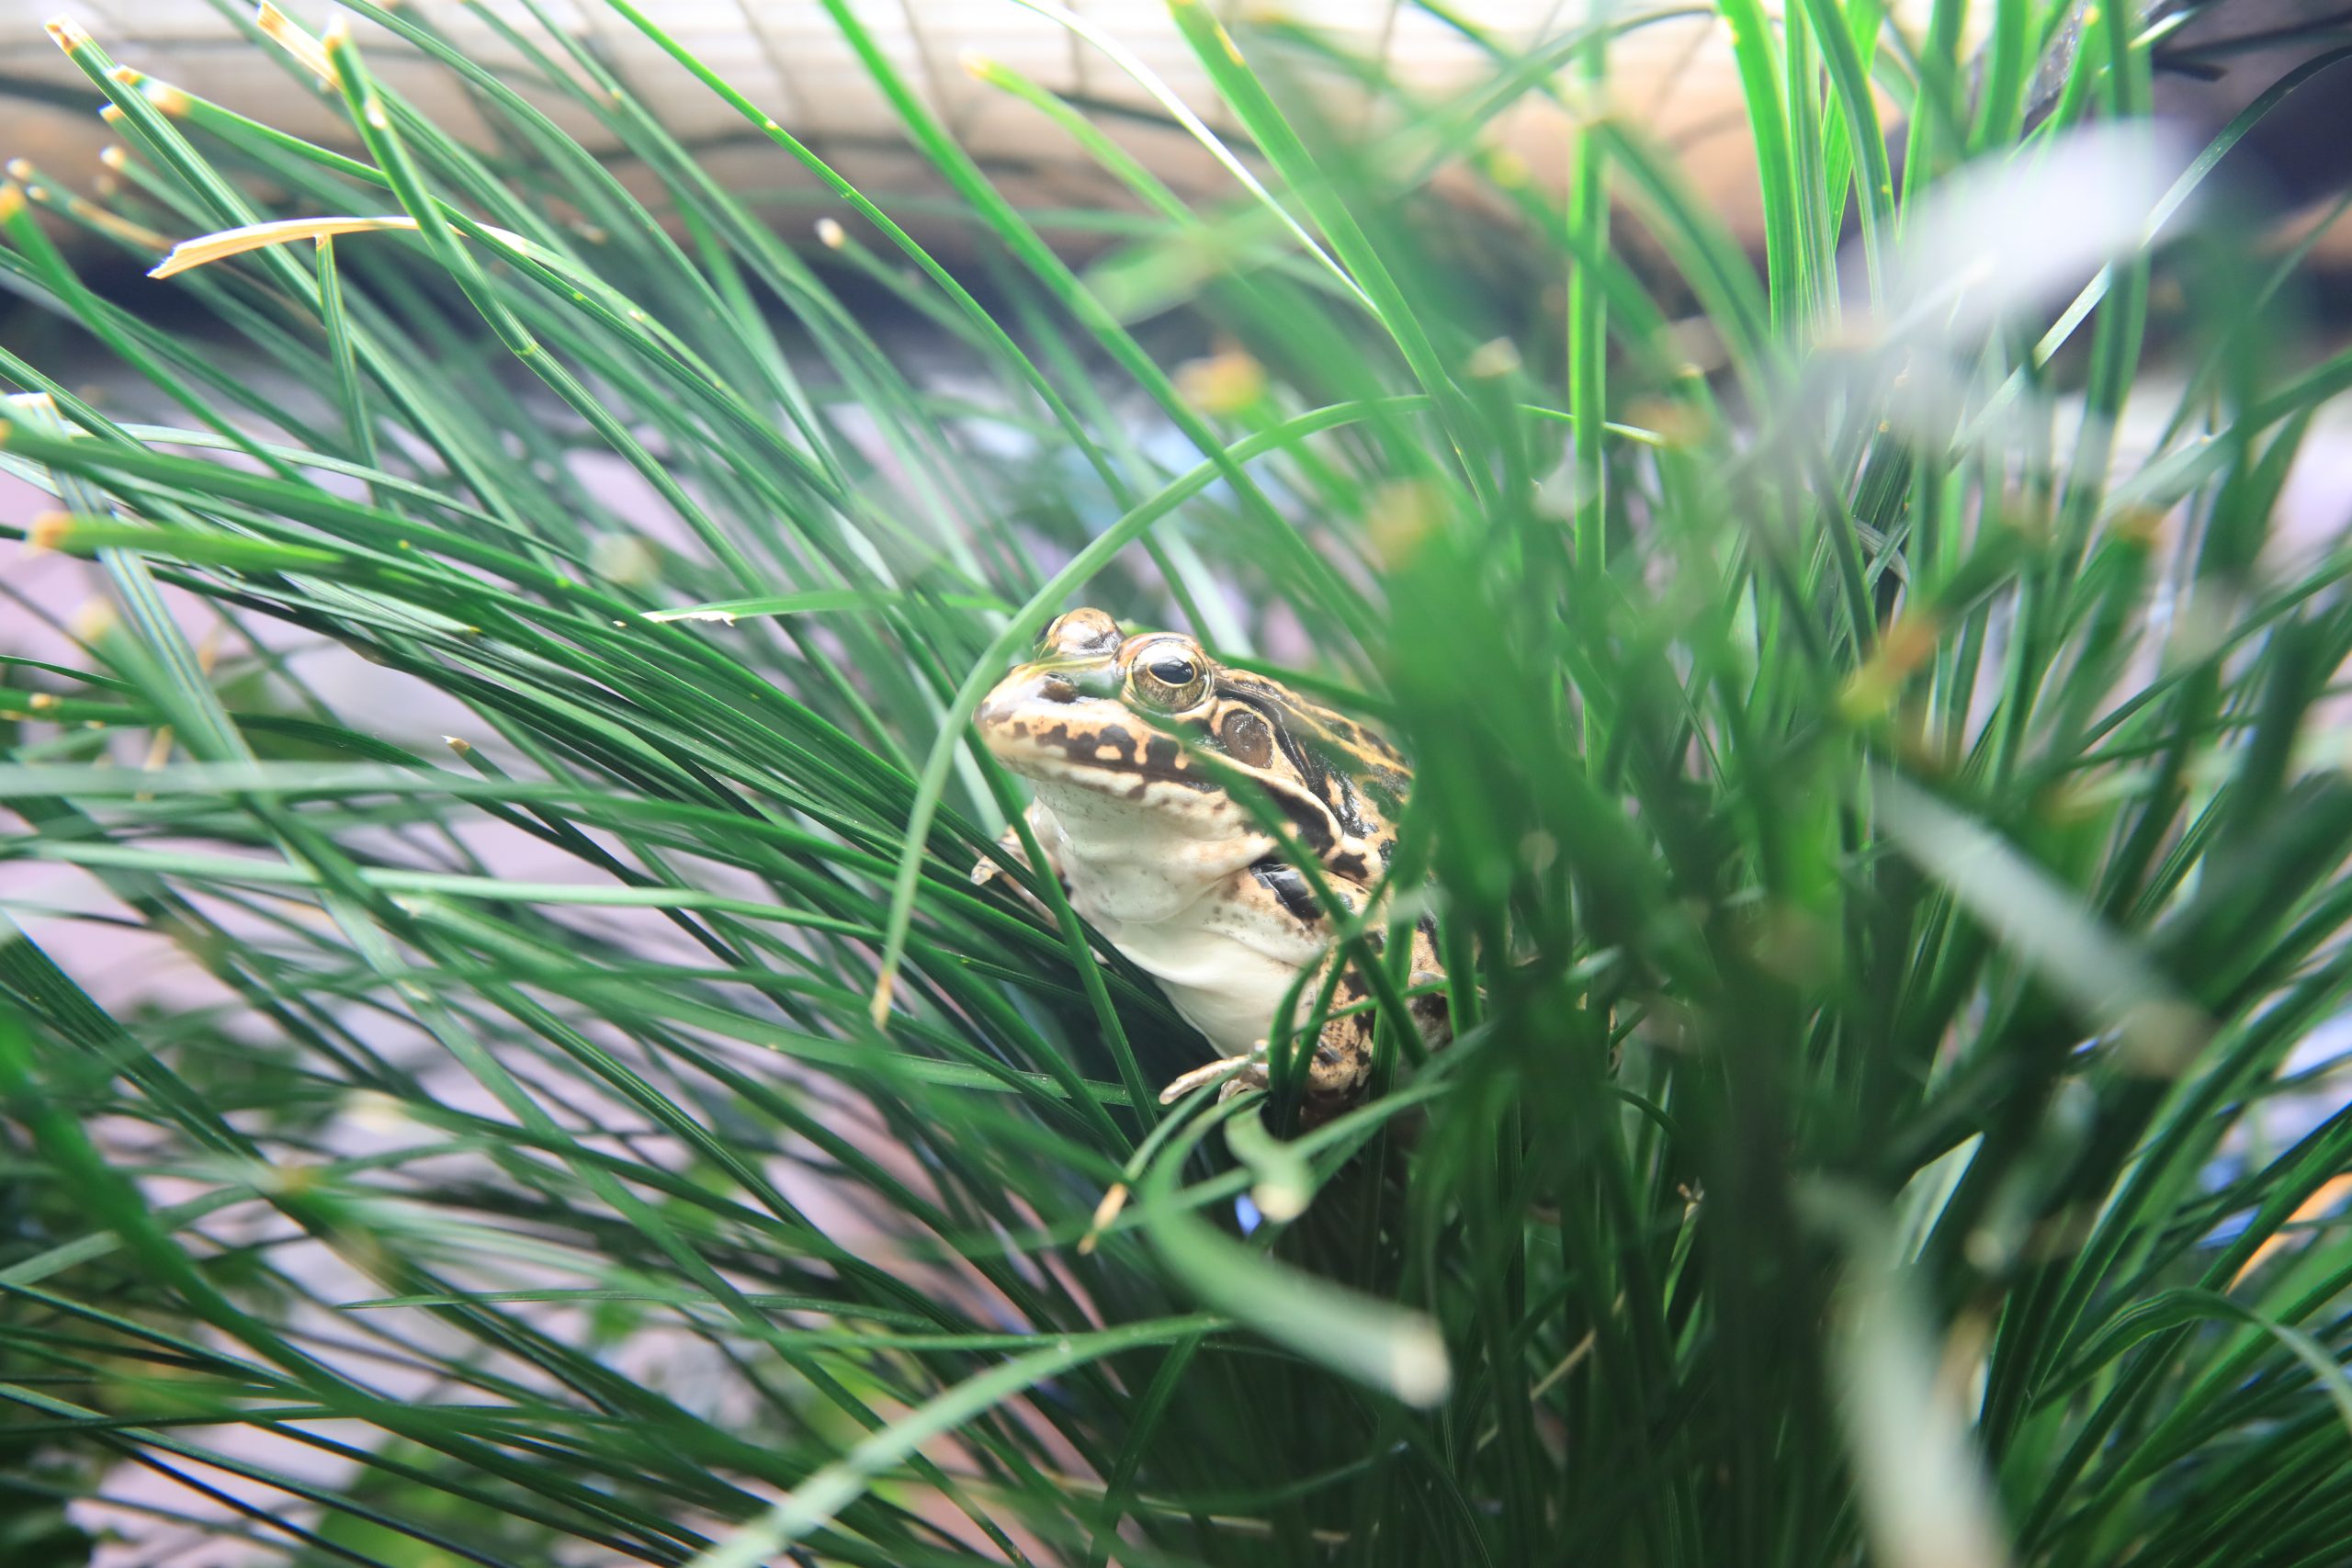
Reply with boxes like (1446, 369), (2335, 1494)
(0, 0), (2352, 1568)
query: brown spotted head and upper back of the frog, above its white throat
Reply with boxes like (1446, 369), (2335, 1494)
(976, 609), (1408, 882)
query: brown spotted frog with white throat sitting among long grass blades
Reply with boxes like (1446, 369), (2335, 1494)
(974, 609), (1449, 1123)
